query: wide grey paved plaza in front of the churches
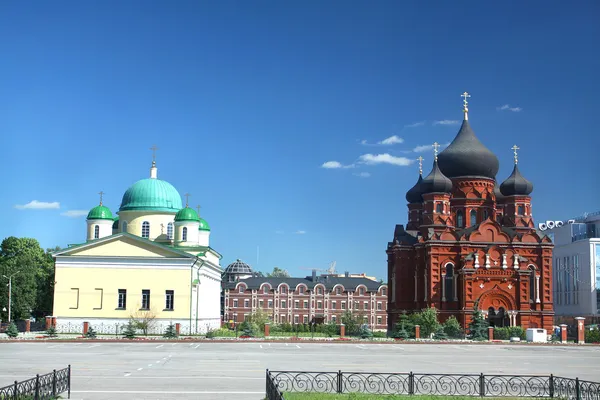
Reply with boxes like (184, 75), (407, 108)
(0, 342), (600, 400)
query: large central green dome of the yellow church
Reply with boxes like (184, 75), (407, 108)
(119, 178), (183, 212)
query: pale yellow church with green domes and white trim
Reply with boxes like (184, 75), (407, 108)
(53, 156), (222, 334)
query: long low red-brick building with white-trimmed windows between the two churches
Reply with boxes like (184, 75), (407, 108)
(223, 260), (388, 330)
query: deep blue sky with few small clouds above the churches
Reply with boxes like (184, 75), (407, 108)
(0, 0), (600, 279)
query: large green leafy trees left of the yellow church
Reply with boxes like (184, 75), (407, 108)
(0, 236), (54, 321)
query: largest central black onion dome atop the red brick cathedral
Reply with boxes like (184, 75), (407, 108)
(438, 120), (500, 179)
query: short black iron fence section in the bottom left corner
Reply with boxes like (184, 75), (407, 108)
(0, 365), (71, 400)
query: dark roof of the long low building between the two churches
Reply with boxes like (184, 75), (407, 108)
(225, 276), (382, 292)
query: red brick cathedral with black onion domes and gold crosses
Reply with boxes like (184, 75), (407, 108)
(386, 93), (554, 332)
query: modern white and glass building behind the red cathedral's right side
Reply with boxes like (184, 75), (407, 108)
(539, 212), (600, 317)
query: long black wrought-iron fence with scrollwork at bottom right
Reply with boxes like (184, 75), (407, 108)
(266, 370), (600, 400)
